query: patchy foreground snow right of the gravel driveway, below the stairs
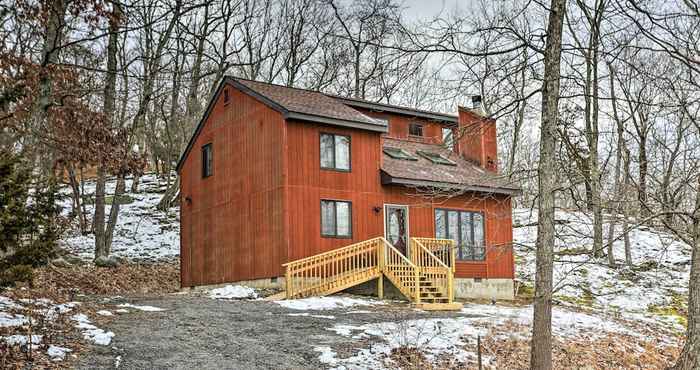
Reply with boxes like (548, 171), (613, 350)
(314, 304), (675, 369)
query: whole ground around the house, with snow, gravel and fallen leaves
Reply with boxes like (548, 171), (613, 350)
(0, 175), (689, 369)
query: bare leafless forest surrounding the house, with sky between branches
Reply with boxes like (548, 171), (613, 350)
(0, 0), (700, 370)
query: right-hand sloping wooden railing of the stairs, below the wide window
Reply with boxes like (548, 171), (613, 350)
(408, 238), (454, 303)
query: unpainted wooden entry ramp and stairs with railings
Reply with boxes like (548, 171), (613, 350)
(283, 237), (462, 310)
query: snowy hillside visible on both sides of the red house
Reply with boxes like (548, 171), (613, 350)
(62, 175), (690, 330)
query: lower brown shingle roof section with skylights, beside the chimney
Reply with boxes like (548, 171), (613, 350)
(382, 138), (520, 194)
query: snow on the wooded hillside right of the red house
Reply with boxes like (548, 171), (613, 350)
(513, 209), (690, 330)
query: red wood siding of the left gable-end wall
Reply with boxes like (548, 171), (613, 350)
(180, 86), (287, 286)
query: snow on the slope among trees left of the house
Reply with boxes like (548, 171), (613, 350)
(60, 174), (180, 262)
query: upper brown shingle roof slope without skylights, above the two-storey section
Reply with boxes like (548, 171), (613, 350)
(231, 78), (386, 128)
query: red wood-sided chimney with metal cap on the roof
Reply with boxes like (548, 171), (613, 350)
(457, 105), (498, 172)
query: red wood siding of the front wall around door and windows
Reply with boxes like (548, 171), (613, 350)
(285, 121), (514, 278)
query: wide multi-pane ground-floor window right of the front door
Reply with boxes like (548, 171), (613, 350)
(435, 209), (486, 261)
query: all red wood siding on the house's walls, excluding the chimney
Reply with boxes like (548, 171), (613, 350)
(180, 86), (514, 287)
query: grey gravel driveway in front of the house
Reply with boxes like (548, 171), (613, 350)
(78, 293), (460, 369)
